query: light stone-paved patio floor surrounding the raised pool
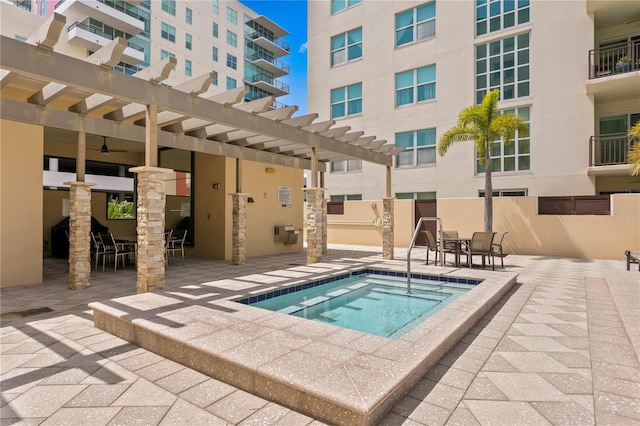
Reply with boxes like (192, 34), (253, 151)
(0, 245), (640, 425)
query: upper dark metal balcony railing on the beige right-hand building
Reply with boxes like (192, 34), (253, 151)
(589, 41), (640, 78)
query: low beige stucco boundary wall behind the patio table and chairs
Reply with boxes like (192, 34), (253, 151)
(328, 194), (640, 259)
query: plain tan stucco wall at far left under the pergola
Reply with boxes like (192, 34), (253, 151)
(0, 120), (44, 287)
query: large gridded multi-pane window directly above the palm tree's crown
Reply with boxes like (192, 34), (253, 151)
(476, 33), (529, 103)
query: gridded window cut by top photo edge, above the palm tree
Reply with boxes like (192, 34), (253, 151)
(476, 0), (530, 36)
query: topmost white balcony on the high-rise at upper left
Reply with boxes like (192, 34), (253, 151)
(56, 0), (144, 35)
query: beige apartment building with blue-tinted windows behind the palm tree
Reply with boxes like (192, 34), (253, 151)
(308, 0), (640, 201)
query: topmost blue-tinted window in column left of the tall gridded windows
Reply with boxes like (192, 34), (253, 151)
(396, 2), (436, 46)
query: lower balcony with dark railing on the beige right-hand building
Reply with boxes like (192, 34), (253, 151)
(589, 133), (640, 176)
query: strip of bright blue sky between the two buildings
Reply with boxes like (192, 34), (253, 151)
(240, 0), (307, 115)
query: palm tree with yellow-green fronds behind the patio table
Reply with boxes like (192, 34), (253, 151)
(438, 89), (529, 232)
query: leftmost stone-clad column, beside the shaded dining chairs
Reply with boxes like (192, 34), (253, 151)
(64, 182), (95, 290)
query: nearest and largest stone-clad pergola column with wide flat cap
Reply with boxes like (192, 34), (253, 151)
(129, 166), (173, 293)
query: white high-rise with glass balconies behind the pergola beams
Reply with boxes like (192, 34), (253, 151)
(2, 0), (289, 103)
